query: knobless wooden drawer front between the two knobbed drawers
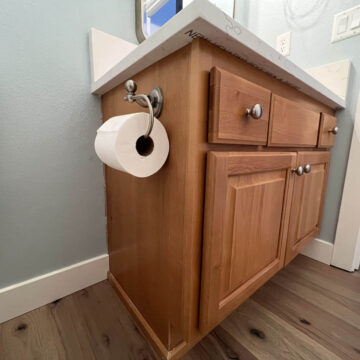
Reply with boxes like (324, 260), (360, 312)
(268, 94), (320, 147)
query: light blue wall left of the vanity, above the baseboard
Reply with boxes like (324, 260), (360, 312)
(0, 0), (136, 288)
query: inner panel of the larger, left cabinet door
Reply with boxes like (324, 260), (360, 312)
(222, 170), (286, 298)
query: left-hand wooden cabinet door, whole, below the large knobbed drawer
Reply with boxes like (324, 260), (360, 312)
(200, 152), (296, 331)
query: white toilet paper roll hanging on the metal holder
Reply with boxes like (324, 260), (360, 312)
(95, 112), (169, 177)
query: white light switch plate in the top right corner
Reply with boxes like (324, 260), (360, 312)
(331, 5), (360, 43)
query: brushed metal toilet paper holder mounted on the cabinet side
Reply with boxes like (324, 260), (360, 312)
(124, 80), (164, 138)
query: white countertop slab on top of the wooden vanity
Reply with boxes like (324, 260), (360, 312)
(91, 0), (345, 109)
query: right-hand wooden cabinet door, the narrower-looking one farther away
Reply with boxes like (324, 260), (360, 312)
(286, 151), (330, 264)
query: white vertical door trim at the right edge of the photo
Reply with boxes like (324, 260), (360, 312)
(331, 95), (360, 271)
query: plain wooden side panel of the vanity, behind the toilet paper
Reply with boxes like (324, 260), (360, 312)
(102, 47), (190, 349)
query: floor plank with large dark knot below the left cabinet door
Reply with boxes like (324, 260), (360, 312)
(220, 299), (341, 360)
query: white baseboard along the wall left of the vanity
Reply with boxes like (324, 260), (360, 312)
(0, 254), (109, 323)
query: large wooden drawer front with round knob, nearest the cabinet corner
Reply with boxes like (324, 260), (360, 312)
(208, 67), (271, 145)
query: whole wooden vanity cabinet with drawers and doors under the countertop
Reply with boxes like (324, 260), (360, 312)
(102, 39), (336, 359)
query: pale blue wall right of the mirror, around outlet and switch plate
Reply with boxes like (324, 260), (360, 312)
(236, 0), (360, 242)
